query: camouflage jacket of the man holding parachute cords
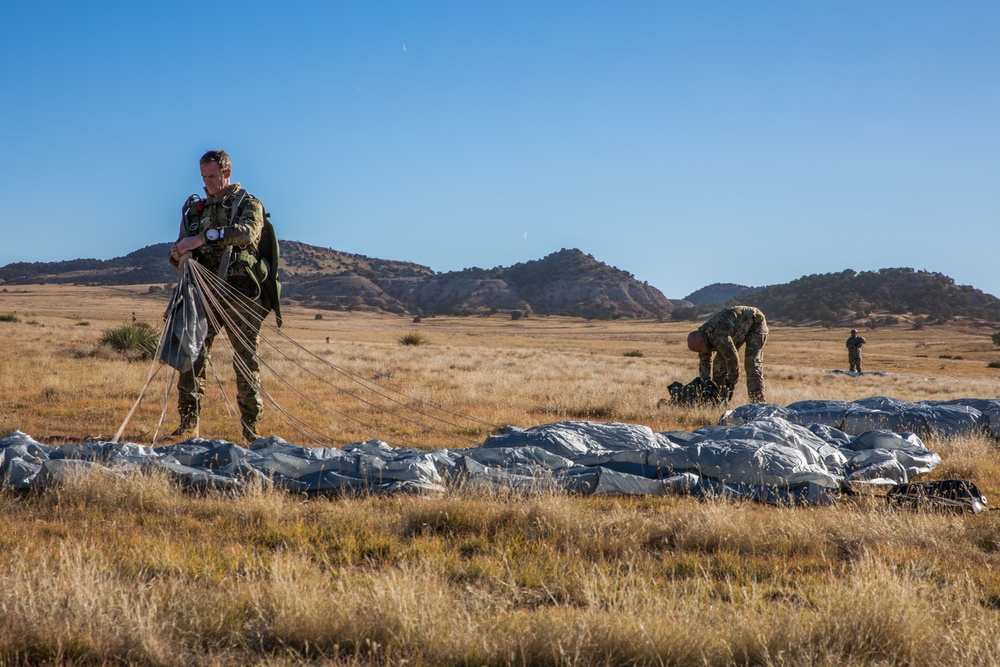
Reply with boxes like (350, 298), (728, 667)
(171, 183), (264, 286)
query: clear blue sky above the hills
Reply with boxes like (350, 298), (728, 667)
(0, 0), (1000, 298)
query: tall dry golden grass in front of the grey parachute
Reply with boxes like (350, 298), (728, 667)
(0, 474), (1000, 665)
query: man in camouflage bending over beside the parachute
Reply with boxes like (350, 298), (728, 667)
(688, 306), (767, 403)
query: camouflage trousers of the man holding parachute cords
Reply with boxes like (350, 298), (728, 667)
(177, 294), (264, 430)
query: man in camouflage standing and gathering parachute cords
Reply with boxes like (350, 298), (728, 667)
(170, 150), (267, 442)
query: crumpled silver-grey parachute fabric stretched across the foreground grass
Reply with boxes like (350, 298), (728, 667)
(0, 398), (984, 504)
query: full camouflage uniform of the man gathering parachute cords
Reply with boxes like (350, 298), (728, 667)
(177, 183), (267, 438)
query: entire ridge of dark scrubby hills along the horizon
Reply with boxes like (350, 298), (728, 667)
(7, 248), (1000, 326)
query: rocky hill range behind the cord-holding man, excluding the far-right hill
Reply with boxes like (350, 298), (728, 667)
(0, 241), (675, 319)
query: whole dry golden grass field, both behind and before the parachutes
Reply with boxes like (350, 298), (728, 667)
(0, 285), (1000, 666)
